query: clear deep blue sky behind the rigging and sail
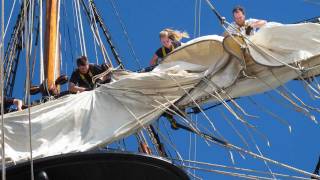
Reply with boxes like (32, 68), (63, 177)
(5, 0), (320, 179)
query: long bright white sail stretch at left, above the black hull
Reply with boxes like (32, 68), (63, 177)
(4, 62), (212, 162)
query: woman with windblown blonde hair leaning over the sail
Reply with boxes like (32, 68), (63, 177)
(150, 28), (189, 66)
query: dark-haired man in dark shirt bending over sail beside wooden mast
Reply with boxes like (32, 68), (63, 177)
(69, 56), (105, 93)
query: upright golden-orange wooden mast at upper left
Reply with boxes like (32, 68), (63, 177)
(44, 0), (60, 88)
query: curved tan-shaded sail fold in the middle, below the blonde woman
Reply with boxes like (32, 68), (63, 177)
(162, 35), (241, 107)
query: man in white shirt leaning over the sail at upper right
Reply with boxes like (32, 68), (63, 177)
(224, 6), (267, 36)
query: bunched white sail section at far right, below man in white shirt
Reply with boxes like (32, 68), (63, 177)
(248, 23), (320, 67)
